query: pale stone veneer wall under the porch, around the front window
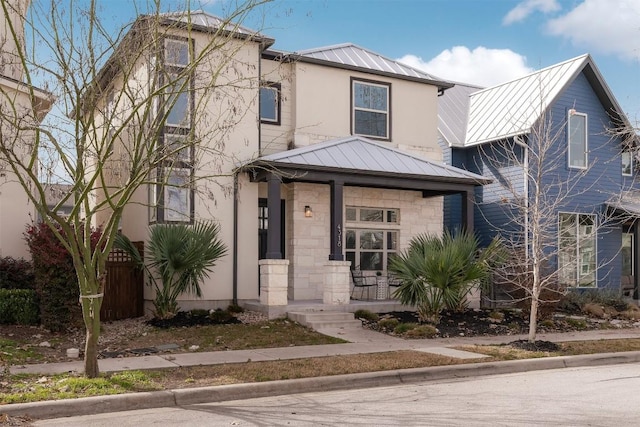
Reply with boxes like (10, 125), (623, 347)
(286, 183), (442, 300)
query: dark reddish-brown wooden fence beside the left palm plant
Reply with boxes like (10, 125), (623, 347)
(100, 242), (144, 321)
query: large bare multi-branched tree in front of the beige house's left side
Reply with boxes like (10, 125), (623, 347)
(0, 0), (268, 377)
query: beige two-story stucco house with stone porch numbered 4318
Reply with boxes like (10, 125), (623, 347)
(96, 12), (486, 314)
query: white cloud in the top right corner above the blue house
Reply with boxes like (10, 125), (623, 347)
(546, 0), (640, 59)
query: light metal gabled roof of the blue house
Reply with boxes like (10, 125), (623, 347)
(465, 54), (626, 146)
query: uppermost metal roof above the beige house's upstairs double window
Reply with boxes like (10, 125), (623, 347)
(267, 43), (453, 89)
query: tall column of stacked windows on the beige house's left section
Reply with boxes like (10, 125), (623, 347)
(149, 38), (194, 223)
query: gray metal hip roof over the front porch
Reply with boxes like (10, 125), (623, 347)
(258, 136), (488, 182)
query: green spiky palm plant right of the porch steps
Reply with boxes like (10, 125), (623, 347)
(389, 231), (500, 324)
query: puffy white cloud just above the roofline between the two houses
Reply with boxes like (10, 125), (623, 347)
(398, 46), (533, 87)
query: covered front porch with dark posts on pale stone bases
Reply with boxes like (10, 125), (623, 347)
(243, 136), (487, 316)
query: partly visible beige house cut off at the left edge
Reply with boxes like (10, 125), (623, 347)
(0, 0), (52, 258)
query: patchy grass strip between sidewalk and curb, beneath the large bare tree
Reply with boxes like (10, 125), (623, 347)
(0, 351), (466, 404)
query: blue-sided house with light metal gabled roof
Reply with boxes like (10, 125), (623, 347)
(439, 55), (640, 299)
